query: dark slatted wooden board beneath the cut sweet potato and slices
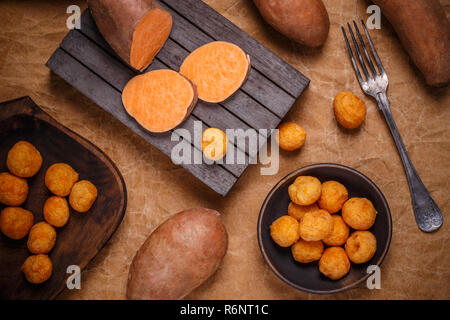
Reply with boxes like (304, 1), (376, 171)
(47, 0), (309, 196)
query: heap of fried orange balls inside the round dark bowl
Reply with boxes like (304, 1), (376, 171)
(270, 176), (377, 280)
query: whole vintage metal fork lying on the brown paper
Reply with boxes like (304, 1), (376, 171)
(341, 20), (442, 232)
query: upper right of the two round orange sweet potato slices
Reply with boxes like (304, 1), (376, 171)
(180, 41), (250, 103)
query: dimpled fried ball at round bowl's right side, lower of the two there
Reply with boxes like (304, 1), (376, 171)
(345, 231), (377, 264)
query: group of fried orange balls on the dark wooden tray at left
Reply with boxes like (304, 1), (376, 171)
(0, 141), (97, 284)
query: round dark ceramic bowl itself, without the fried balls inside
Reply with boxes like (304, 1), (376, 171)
(257, 163), (392, 294)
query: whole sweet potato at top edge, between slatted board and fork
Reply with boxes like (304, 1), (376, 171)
(253, 0), (330, 47)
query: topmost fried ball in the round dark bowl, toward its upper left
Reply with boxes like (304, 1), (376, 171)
(288, 176), (322, 206)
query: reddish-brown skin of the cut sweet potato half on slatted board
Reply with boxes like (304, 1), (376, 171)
(88, 0), (172, 70)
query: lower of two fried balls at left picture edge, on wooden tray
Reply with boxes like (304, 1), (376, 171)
(0, 207), (34, 240)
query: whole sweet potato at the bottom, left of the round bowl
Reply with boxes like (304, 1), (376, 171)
(127, 208), (228, 300)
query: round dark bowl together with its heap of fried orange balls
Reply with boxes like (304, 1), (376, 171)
(257, 163), (392, 294)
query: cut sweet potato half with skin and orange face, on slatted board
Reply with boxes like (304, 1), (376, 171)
(88, 0), (172, 70)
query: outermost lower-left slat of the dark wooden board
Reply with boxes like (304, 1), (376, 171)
(47, 49), (237, 195)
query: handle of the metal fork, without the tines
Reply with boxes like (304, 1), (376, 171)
(376, 93), (442, 232)
